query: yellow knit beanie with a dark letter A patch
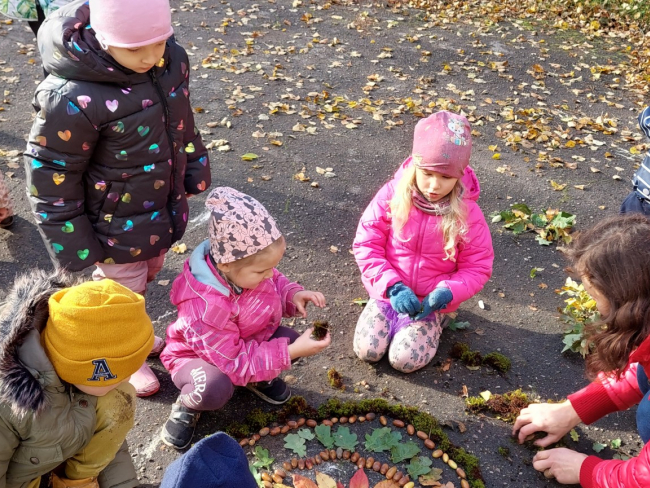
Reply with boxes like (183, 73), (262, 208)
(41, 280), (154, 386)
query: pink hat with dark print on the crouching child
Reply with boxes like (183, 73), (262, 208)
(205, 186), (282, 264)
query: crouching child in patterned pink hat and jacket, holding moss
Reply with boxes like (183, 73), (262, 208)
(160, 187), (330, 449)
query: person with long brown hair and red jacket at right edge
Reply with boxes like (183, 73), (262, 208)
(513, 213), (650, 488)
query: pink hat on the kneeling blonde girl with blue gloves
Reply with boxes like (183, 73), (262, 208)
(411, 110), (472, 178)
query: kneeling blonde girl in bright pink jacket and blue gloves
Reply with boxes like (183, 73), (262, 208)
(353, 111), (494, 373)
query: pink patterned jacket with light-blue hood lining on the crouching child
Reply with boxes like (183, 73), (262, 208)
(160, 241), (303, 386)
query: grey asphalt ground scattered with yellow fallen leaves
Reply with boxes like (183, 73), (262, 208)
(0, 0), (646, 487)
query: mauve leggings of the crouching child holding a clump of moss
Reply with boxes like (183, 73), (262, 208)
(172, 325), (300, 410)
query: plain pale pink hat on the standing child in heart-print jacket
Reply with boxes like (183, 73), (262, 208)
(89, 0), (174, 48)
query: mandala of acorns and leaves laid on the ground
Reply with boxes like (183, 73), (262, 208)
(240, 400), (476, 488)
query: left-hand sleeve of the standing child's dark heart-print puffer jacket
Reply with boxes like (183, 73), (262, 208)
(24, 90), (104, 271)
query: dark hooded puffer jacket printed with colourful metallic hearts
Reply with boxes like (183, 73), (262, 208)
(25, 2), (210, 271)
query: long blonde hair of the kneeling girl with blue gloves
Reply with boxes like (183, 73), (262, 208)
(389, 165), (468, 261)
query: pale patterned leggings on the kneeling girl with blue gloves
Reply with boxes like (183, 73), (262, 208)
(353, 298), (445, 373)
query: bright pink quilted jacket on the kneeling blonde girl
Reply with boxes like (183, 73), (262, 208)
(353, 158), (494, 312)
